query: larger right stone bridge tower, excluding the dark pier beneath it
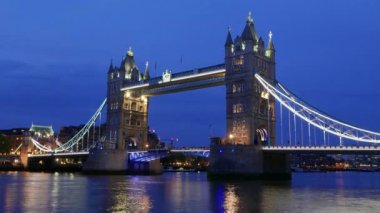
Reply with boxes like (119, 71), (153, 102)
(225, 14), (276, 145)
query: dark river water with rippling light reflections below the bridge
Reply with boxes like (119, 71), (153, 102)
(0, 172), (380, 213)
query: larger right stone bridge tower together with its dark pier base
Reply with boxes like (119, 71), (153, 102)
(209, 14), (291, 179)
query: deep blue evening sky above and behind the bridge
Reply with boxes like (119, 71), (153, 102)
(0, 0), (380, 146)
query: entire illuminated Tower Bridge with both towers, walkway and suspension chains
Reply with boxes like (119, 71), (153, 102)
(21, 12), (380, 178)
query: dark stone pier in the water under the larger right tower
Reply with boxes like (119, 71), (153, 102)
(208, 144), (291, 180)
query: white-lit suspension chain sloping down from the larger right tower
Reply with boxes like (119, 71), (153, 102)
(255, 74), (380, 145)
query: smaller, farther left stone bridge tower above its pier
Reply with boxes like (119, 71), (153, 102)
(107, 48), (149, 150)
